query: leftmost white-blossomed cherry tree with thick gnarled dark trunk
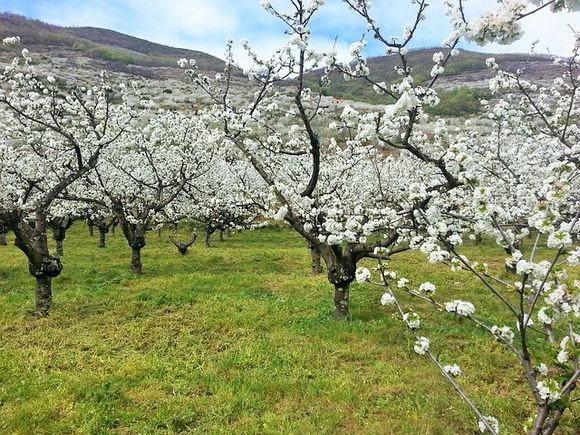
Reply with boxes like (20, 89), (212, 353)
(0, 38), (134, 315)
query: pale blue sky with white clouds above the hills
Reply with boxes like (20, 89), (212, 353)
(0, 0), (580, 65)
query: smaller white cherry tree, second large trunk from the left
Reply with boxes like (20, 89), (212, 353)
(84, 109), (220, 274)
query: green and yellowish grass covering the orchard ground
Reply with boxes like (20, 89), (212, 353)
(0, 225), (580, 434)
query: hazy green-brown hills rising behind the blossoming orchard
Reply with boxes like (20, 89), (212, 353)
(0, 13), (561, 116)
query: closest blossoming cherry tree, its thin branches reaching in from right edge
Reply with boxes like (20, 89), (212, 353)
(343, 2), (580, 434)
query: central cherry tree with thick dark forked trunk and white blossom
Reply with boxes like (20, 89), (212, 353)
(179, 1), (455, 318)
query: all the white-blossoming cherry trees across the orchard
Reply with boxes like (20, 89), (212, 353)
(0, 0), (580, 434)
